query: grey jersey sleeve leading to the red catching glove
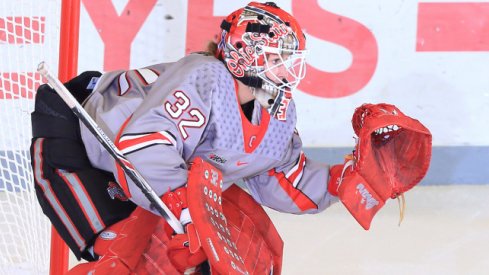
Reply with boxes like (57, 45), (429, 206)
(245, 133), (338, 214)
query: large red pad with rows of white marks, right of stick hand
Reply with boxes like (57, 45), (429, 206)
(187, 158), (283, 274)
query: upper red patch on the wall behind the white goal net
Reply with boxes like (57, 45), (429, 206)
(0, 16), (46, 44)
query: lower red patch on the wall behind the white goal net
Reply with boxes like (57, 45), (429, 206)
(0, 72), (42, 99)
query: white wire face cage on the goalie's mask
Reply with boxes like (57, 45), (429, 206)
(255, 46), (308, 94)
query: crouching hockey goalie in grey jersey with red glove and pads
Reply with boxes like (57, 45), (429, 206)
(31, 2), (431, 274)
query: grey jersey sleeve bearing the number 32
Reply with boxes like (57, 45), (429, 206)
(113, 75), (212, 213)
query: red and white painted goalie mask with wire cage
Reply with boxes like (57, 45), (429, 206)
(216, 2), (306, 120)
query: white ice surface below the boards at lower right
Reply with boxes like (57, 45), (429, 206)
(268, 185), (489, 275)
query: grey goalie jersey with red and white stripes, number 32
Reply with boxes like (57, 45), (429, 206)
(81, 54), (337, 214)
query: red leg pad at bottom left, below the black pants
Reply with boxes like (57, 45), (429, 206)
(68, 207), (182, 275)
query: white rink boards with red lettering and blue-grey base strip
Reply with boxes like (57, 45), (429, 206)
(0, 0), (489, 183)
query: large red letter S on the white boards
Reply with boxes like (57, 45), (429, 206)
(292, 0), (378, 98)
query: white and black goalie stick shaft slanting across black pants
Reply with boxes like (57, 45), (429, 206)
(37, 62), (184, 234)
